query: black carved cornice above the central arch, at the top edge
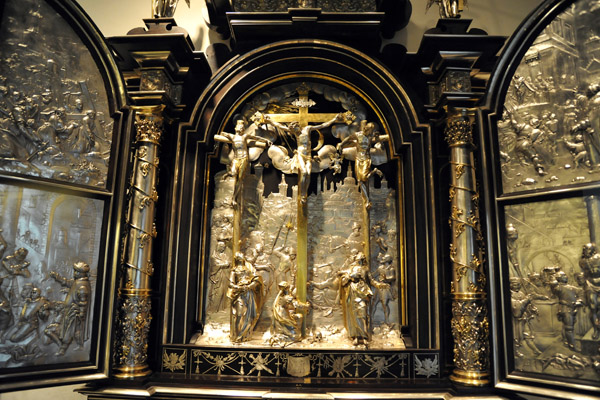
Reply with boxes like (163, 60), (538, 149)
(206, 0), (412, 48)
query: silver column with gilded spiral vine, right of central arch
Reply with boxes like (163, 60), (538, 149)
(445, 110), (490, 386)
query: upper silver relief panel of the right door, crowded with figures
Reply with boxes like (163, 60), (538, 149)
(498, 0), (600, 192)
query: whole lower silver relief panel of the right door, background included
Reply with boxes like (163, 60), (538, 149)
(506, 196), (600, 380)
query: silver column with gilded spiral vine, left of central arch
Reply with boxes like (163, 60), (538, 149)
(114, 105), (164, 378)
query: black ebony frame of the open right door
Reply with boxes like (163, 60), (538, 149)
(478, 0), (600, 398)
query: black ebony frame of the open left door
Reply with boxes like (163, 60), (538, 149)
(0, 0), (133, 391)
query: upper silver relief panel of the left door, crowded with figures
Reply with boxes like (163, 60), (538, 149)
(0, 0), (113, 187)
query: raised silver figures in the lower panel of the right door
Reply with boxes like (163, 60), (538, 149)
(506, 224), (600, 376)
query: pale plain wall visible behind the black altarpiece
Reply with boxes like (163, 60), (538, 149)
(0, 0), (542, 400)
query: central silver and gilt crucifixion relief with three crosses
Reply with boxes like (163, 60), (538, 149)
(194, 83), (404, 348)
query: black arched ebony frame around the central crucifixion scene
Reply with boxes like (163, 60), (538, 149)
(159, 40), (444, 379)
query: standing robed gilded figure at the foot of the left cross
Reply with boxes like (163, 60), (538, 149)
(227, 252), (264, 342)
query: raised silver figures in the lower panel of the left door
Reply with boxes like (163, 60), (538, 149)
(0, 233), (92, 364)
